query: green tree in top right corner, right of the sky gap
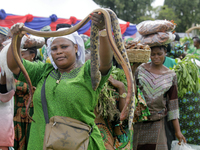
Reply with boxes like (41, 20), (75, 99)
(164, 0), (200, 32)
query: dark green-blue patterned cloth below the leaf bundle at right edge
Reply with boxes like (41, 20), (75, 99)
(179, 90), (200, 145)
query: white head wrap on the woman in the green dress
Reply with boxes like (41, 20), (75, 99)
(47, 28), (85, 69)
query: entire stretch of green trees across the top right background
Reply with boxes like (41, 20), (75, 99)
(94, 0), (200, 32)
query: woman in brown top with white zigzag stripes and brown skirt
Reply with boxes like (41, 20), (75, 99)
(132, 46), (186, 150)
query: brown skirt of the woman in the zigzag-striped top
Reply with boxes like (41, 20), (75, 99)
(133, 118), (168, 150)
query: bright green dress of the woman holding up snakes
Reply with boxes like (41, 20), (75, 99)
(16, 60), (110, 150)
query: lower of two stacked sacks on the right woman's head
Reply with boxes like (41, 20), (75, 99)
(140, 32), (175, 47)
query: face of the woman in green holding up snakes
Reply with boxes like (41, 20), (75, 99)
(51, 37), (78, 69)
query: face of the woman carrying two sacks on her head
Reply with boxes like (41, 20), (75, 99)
(151, 47), (165, 65)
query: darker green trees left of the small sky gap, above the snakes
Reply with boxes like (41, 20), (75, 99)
(94, 0), (154, 24)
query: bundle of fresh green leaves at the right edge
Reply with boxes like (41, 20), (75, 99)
(173, 54), (200, 98)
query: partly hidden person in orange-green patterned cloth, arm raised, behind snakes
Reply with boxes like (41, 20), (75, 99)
(94, 75), (130, 150)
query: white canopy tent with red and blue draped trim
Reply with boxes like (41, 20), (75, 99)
(0, 0), (137, 36)
